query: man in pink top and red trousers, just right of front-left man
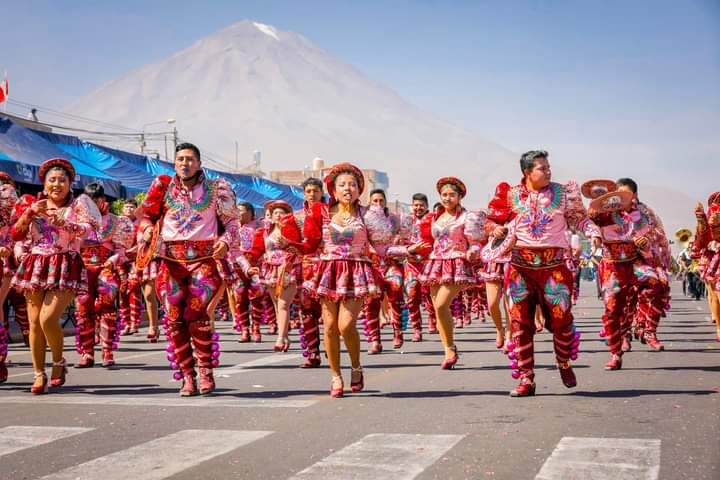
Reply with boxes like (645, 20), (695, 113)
(228, 202), (265, 343)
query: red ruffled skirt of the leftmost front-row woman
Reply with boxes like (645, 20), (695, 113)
(12, 252), (87, 292)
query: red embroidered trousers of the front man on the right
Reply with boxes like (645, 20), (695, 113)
(508, 262), (573, 380)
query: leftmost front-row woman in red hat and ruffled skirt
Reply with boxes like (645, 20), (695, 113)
(12, 158), (102, 395)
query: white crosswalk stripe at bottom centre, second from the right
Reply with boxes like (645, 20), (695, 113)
(292, 433), (464, 480)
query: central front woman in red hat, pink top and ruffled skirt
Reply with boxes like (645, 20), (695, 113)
(303, 163), (400, 397)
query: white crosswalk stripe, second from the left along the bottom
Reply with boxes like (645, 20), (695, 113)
(42, 430), (272, 480)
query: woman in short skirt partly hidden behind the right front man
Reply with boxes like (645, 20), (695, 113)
(480, 182), (512, 348)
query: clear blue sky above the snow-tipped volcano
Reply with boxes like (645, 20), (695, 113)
(0, 0), (720, 191)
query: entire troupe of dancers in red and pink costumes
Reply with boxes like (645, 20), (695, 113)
(0, 143), (704, 397)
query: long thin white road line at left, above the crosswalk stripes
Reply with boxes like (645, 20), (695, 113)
(0, 395), (317, 408)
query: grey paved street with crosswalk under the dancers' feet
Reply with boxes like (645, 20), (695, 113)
(0, 283), (720, 480)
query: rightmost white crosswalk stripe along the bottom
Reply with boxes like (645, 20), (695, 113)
(535, 437), (660, 480)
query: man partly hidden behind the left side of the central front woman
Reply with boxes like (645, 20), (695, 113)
(295, 177), (323, 368)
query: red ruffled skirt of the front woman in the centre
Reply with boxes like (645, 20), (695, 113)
(304, 260), (382, 300)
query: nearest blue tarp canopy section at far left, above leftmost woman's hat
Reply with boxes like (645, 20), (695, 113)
(0, 117), (121, 197)
